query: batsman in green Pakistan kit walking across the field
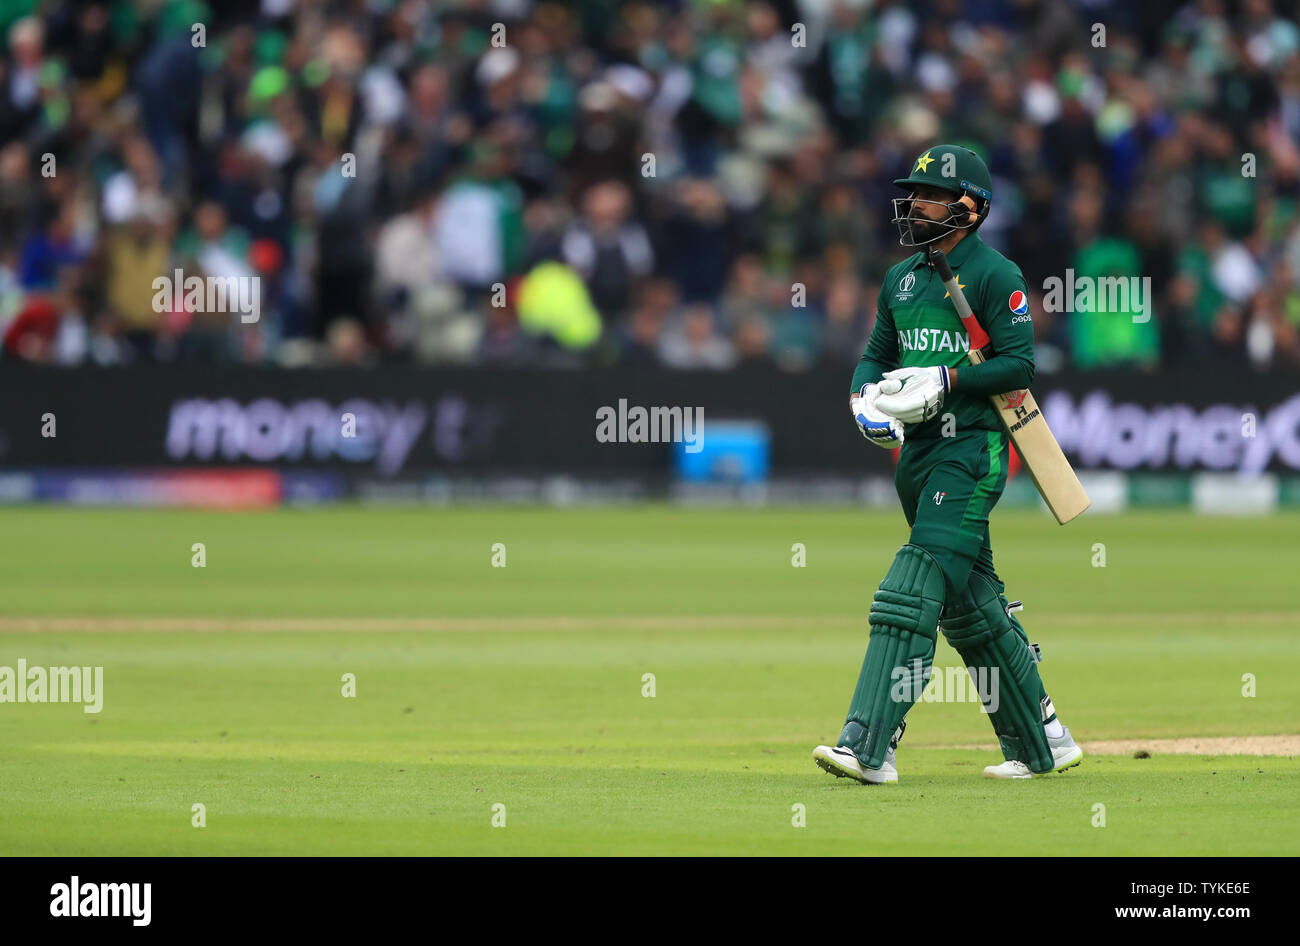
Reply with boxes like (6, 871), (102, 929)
(813, 144), (1083, 785)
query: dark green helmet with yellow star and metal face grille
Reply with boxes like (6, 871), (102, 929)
(893, 144), (993, 247)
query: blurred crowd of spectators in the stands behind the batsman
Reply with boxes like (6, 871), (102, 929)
(0, 0), (1300, 372)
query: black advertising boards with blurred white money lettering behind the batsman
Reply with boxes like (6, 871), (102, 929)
(0, 364), (1300, 478)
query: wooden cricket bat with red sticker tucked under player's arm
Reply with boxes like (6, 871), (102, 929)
(930, 247), (1092, 525)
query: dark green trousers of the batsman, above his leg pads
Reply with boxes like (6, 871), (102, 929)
(894, 430), (1009, 598)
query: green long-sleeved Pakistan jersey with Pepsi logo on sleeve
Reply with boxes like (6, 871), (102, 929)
(853, 233), (1034, 441)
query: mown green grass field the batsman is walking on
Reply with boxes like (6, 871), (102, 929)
(0, 507), (1300, 855)
